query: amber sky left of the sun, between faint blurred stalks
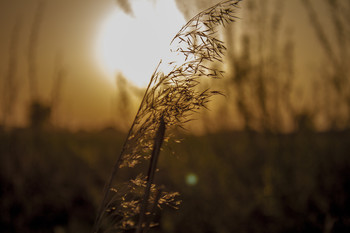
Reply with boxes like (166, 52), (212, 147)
(0, 0), (114, 129)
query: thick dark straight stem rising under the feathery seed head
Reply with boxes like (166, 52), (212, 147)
(136, 117), (165, 233)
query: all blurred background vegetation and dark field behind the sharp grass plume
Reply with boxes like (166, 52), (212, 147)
(0, 0), (350, 233)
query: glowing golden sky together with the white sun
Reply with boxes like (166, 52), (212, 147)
(0, 0), (348, 129)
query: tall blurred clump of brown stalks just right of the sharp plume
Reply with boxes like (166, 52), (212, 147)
(220, 1), (295, 133)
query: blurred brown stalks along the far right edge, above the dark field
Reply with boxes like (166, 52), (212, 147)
(301, 0), (350, 130)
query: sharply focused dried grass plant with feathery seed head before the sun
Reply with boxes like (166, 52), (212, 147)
(93, 0), (241, 233)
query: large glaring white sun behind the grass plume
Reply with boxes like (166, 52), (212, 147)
(96, 0), (185, 87)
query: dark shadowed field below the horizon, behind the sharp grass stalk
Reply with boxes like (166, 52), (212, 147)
(0, 129), (350, 233)
